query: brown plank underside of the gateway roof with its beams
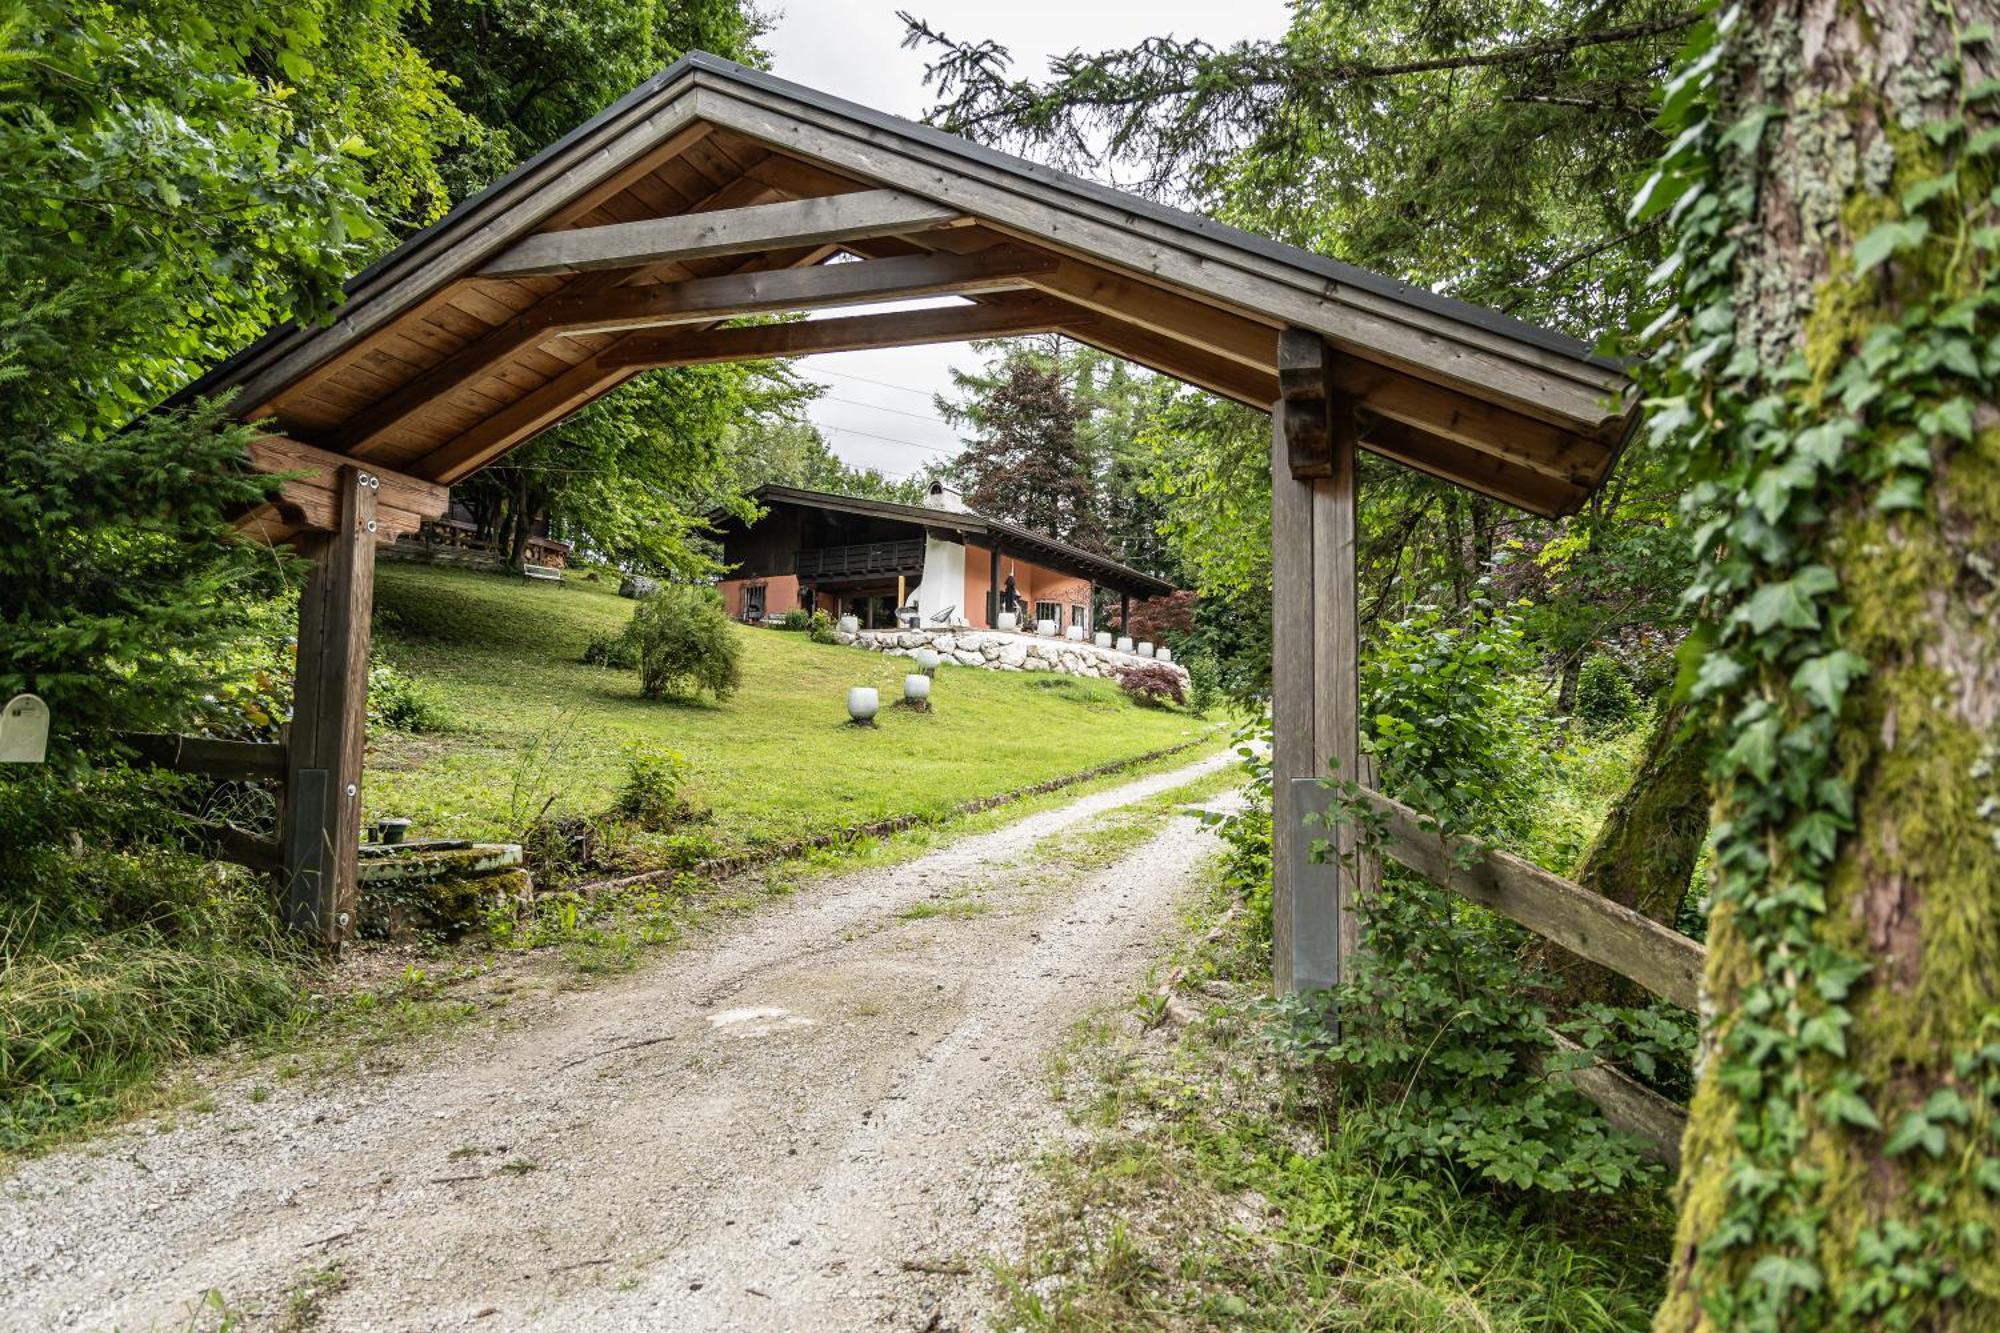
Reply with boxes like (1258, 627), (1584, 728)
(242, 122), (1626, 536)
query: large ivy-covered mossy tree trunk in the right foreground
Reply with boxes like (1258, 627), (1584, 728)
(1636, 0), (2000, 1331)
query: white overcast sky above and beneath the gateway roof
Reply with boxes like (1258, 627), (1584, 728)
(764, 0), (1288, 476)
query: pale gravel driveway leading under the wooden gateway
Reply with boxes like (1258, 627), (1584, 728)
(0, 757), (1226, 1333)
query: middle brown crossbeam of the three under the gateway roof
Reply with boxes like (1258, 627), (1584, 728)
(536, 246), (1054, 334)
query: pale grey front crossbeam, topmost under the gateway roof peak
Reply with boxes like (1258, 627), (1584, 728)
(480, 190), (964, 278)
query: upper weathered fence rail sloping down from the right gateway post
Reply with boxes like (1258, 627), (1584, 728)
(1366, 791), (1708, 1011)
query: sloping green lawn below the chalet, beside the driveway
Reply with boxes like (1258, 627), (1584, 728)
(364, 562), (1214, 847)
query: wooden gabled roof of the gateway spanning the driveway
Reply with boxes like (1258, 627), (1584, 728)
(178, 54), (1634, 528)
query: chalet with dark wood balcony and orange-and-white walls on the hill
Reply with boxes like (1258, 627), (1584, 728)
(720, 484), (1174, 632)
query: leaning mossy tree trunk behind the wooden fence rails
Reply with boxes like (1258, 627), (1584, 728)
(1532, 703), (1708, 1007)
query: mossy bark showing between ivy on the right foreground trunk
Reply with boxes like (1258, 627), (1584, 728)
(1654, 0), (2000, 1333)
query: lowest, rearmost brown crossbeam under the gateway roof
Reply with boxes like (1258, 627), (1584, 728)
(598, 300), (1092, 366)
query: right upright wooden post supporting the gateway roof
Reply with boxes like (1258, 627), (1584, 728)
(1270, 328), (1360, 995)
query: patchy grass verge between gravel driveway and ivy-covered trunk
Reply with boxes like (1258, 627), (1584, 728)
(994, 844), (1672, 1331)
